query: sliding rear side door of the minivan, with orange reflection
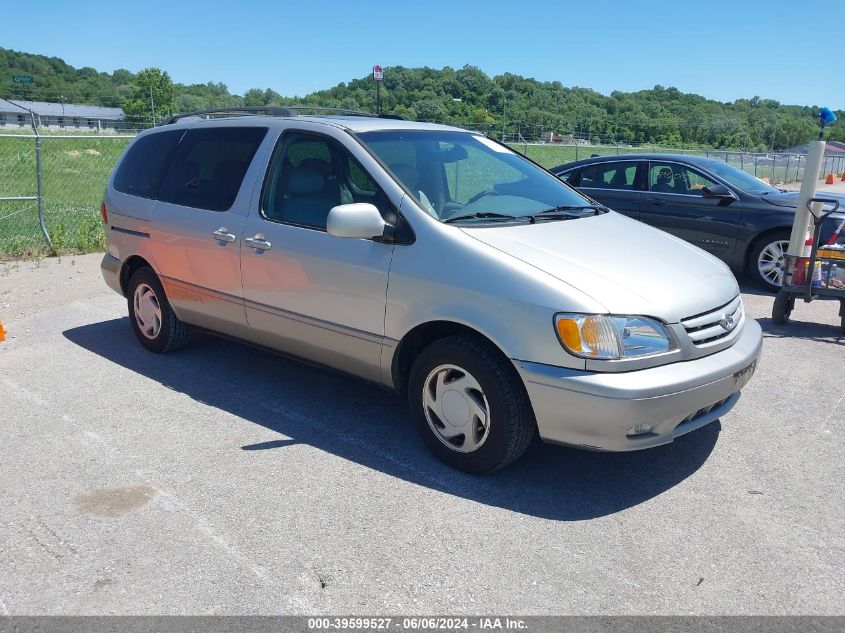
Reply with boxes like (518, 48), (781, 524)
(150, 126), (267, 338)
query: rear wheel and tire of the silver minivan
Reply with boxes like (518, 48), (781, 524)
(126, 267), (191, 354)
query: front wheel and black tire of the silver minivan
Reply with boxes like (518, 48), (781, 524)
(408, 336), (536, 473)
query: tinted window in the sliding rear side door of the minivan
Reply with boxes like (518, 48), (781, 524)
(159, 127), (267, 211)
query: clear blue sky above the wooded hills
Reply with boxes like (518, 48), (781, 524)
(0, 0), (845, 108)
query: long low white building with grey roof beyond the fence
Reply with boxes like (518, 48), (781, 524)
(0, 99), (130, 131)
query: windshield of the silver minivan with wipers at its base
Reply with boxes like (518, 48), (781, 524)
(357, 130), (597, 223)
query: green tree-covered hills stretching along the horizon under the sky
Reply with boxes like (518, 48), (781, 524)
(0, 48), (845, 151)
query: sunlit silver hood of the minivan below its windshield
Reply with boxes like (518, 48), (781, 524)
(461, 211), (739, 323)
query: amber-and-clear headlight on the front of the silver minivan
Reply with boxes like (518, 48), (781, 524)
(555, 314), (676, 360)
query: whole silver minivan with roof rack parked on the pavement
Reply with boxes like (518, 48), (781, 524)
(102, 108), (762, 472)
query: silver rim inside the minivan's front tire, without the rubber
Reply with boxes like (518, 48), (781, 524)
(422, 365), (490, 453)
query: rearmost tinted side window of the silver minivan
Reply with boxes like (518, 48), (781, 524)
(113, 130), (185, 198)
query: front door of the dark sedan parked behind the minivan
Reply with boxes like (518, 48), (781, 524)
(640, 161), (742, 262)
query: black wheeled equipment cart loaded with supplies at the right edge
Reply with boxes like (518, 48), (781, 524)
(772, 198), (845, 332)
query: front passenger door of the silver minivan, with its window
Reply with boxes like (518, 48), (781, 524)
(241, 131), (393, 381)
